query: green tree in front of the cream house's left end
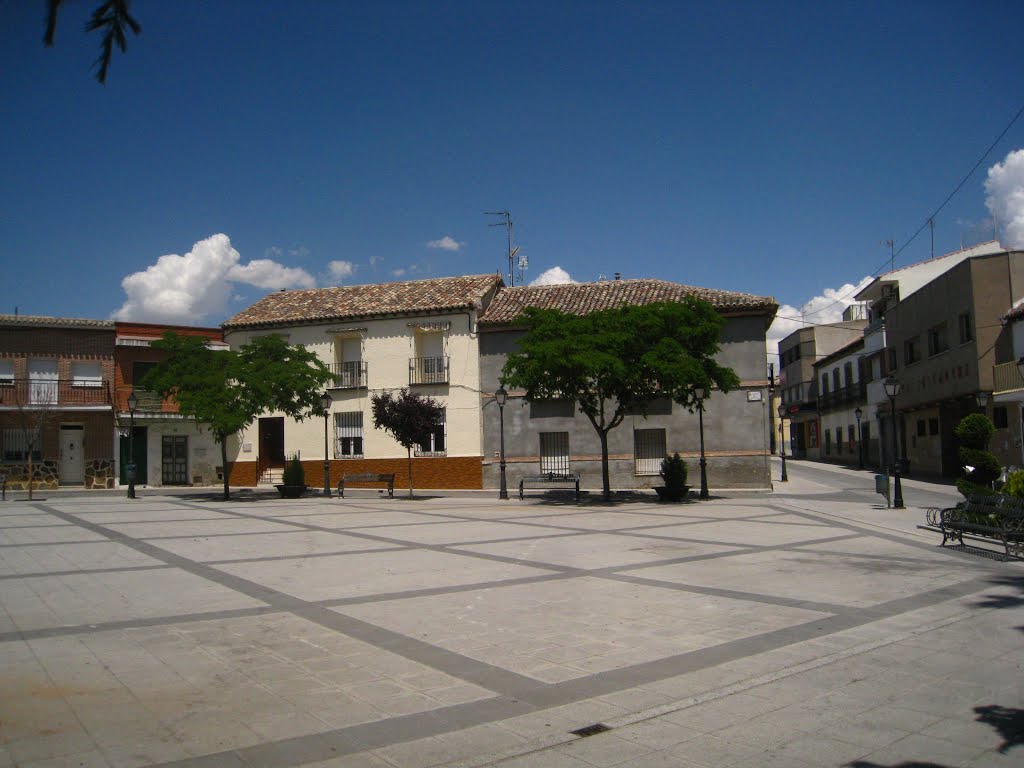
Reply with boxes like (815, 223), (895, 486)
(138, 333), (334, 501)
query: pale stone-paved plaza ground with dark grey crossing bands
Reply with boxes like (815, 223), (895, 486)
(0, 463), (1024, 768)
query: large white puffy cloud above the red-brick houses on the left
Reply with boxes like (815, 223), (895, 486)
(113, 234), (315, 325)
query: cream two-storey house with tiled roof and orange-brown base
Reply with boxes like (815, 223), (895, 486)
(223, 274), (503, 488)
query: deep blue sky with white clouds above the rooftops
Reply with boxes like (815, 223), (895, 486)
(0, 0), (1024, 352)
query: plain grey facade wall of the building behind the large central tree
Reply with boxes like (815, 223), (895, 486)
(480, 316), (771, 492)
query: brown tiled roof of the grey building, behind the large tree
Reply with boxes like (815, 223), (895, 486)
(480, 280), (778, 325)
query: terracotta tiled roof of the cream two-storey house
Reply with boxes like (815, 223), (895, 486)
(222, 274), (502, 329)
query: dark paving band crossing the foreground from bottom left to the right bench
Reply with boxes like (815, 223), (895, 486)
(149, 579), (988, 768)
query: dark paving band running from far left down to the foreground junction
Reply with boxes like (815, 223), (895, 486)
(35, 501), (537, 696)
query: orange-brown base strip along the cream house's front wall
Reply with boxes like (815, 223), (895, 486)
(230, 456), (483, 490)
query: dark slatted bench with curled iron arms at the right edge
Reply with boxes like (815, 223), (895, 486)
(926, 495), (1024, 557)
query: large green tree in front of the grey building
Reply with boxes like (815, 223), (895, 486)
(504, 297), (739, 500)
